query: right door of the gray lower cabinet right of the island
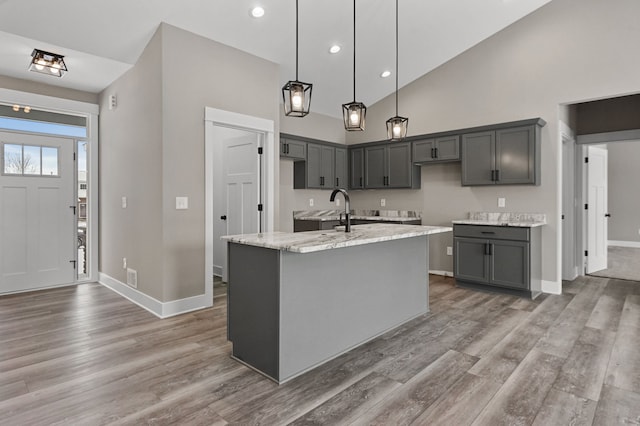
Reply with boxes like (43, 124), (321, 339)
(489, 240), (531, 290)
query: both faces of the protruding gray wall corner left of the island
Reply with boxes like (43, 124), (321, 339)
(100, 24), (279, 301)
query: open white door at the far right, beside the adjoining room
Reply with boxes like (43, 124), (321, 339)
(587, 146), (608, 274)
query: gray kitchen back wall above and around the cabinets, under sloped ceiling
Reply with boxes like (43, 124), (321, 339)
(336, 0), (640, 283)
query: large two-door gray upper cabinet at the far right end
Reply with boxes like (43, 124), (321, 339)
(461, 124), (540, 186)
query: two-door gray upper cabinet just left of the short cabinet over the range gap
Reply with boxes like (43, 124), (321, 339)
(364, 142), (420, 189)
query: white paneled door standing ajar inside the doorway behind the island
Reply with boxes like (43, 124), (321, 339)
(213, 127), (261, 281)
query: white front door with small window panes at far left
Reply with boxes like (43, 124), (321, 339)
(0, 132), (77, 293)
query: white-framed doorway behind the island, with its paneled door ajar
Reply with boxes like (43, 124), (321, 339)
(205, 108), (278, 294)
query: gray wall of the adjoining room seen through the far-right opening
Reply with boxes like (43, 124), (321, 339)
(607, 141), (640, 243)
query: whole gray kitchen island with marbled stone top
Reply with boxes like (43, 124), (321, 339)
(223, 224), (452, 383)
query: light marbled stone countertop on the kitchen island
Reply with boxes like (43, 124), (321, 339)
(222, 223), (453, 253)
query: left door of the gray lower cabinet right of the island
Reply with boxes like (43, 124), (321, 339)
(453, 237), (489, 283)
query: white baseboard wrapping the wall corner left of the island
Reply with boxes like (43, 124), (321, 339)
(98, 272), (213, 318)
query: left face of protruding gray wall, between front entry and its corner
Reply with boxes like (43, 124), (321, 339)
(99, 26), (164, 300)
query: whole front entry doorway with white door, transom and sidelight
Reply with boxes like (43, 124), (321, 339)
(0, 97), (97, 293)
